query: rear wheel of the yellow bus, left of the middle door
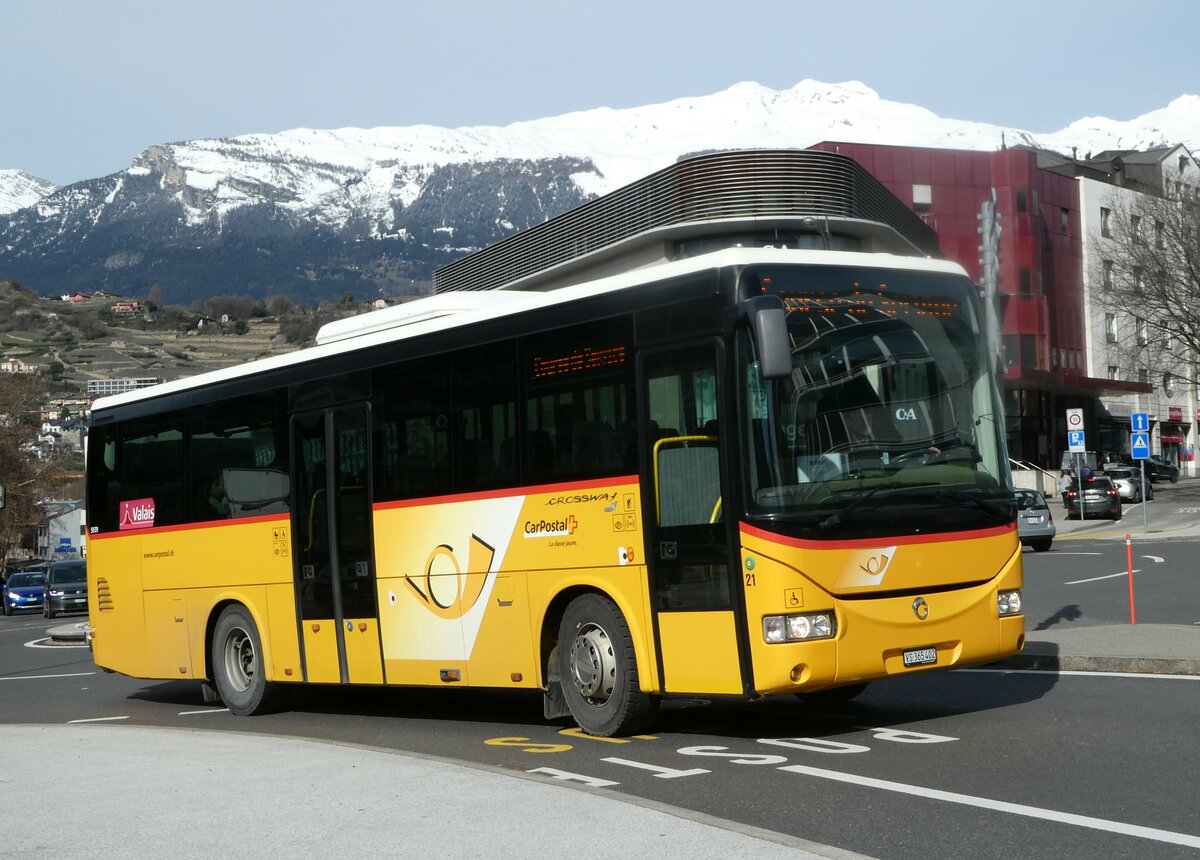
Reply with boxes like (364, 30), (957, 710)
(212, 605), (284, 716)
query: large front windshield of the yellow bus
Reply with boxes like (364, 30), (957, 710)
(738, 266), (1015, 540)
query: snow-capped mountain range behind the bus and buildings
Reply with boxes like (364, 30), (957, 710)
(0, 80), (1200, 301)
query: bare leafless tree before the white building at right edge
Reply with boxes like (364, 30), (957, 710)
(1090, 192), (1200, 385)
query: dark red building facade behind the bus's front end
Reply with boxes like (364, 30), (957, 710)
(812, 142), (1148, 469)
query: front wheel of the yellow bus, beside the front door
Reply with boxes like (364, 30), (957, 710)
(557, 594), (659, 738)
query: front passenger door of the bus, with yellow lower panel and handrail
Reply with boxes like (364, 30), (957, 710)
(638, 341), (743, 694)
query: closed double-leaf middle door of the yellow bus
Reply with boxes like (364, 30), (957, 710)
(292, 404), (383, 684)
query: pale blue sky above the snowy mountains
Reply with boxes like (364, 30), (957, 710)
(0, 0), (1200, 184)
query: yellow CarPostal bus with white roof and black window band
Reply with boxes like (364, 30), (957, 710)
(88, 151), (1024, 735)
